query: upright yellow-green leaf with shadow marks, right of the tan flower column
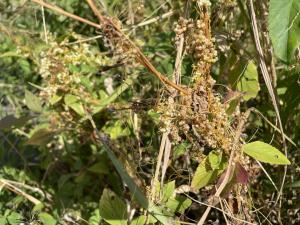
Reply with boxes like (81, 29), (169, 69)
(237, 61), (260, 101)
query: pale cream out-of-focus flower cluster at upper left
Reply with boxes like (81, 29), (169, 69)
(40, 38), (111, 99)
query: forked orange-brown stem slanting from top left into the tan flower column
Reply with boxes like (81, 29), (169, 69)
(32, 0), (188, 95)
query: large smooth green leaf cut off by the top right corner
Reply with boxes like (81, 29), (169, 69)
(268, 0), (300, 62)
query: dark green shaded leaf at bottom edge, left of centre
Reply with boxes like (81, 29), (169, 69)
(99, 189), (127, 225)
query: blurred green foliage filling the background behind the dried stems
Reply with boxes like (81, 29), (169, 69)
(0, 0), (300, 225)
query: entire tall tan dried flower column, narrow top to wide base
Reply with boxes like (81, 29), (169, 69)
(159, 8), (233, 153)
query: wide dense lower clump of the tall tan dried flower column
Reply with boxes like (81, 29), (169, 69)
(159, 76), (233, 153)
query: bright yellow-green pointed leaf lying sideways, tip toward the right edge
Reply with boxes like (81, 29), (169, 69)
(242, 141), (291, 165)
